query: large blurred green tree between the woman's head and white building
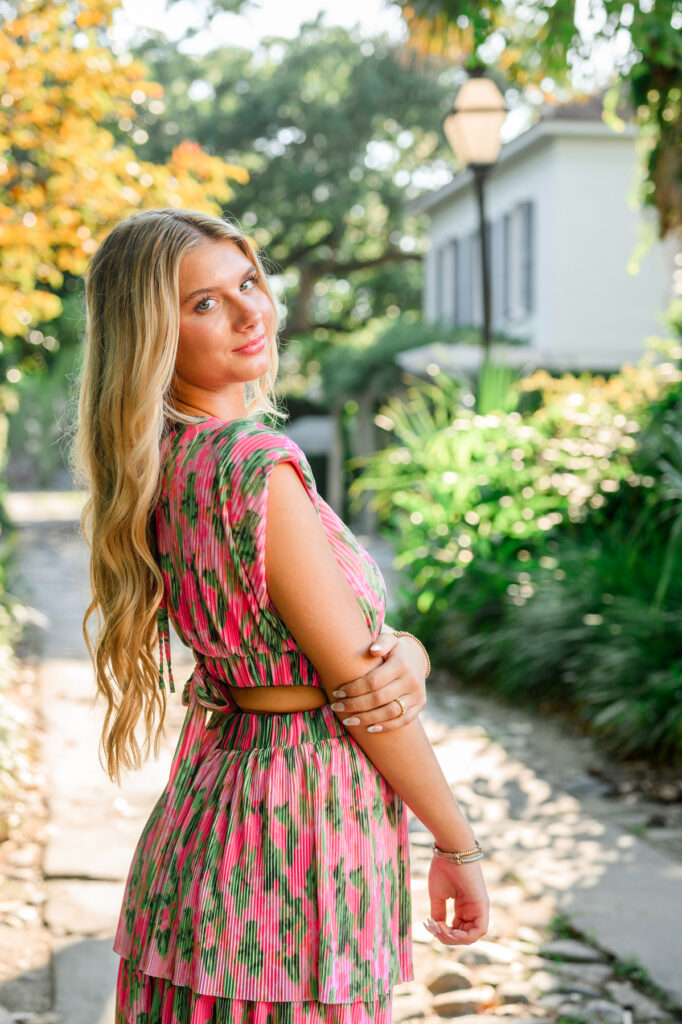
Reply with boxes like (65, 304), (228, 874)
(127, 16), (464, 388)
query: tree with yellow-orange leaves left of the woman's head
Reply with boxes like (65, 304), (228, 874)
(0, 0), (248, 352)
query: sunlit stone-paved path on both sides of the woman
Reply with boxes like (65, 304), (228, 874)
(0, 496), (682, 1024)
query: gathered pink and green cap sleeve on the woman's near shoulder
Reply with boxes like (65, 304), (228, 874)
(219, 424), (319, 609)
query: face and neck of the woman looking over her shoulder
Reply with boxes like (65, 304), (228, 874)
(174, 239), (274, 418)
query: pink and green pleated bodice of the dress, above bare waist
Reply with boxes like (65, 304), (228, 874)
(155, 417), (386, 710)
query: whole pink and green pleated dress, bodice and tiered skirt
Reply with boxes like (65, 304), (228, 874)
(113, 417), (414, 1024)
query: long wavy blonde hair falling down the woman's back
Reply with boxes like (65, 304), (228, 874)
(69, 209), (287, 783)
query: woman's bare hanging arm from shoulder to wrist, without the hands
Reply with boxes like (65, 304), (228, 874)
(264, 462), (473, 850)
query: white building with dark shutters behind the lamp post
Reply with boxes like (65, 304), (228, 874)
(400, 96), (676, 370)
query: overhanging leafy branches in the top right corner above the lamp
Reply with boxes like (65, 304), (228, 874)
(393, 0), (682, 239)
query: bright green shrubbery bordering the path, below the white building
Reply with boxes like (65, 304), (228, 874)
(352, 348), (682, 761)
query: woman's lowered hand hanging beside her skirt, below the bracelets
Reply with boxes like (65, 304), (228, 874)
(426, 856), (489, 946)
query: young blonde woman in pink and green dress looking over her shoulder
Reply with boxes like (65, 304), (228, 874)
(74, 209), (487, 1024)
